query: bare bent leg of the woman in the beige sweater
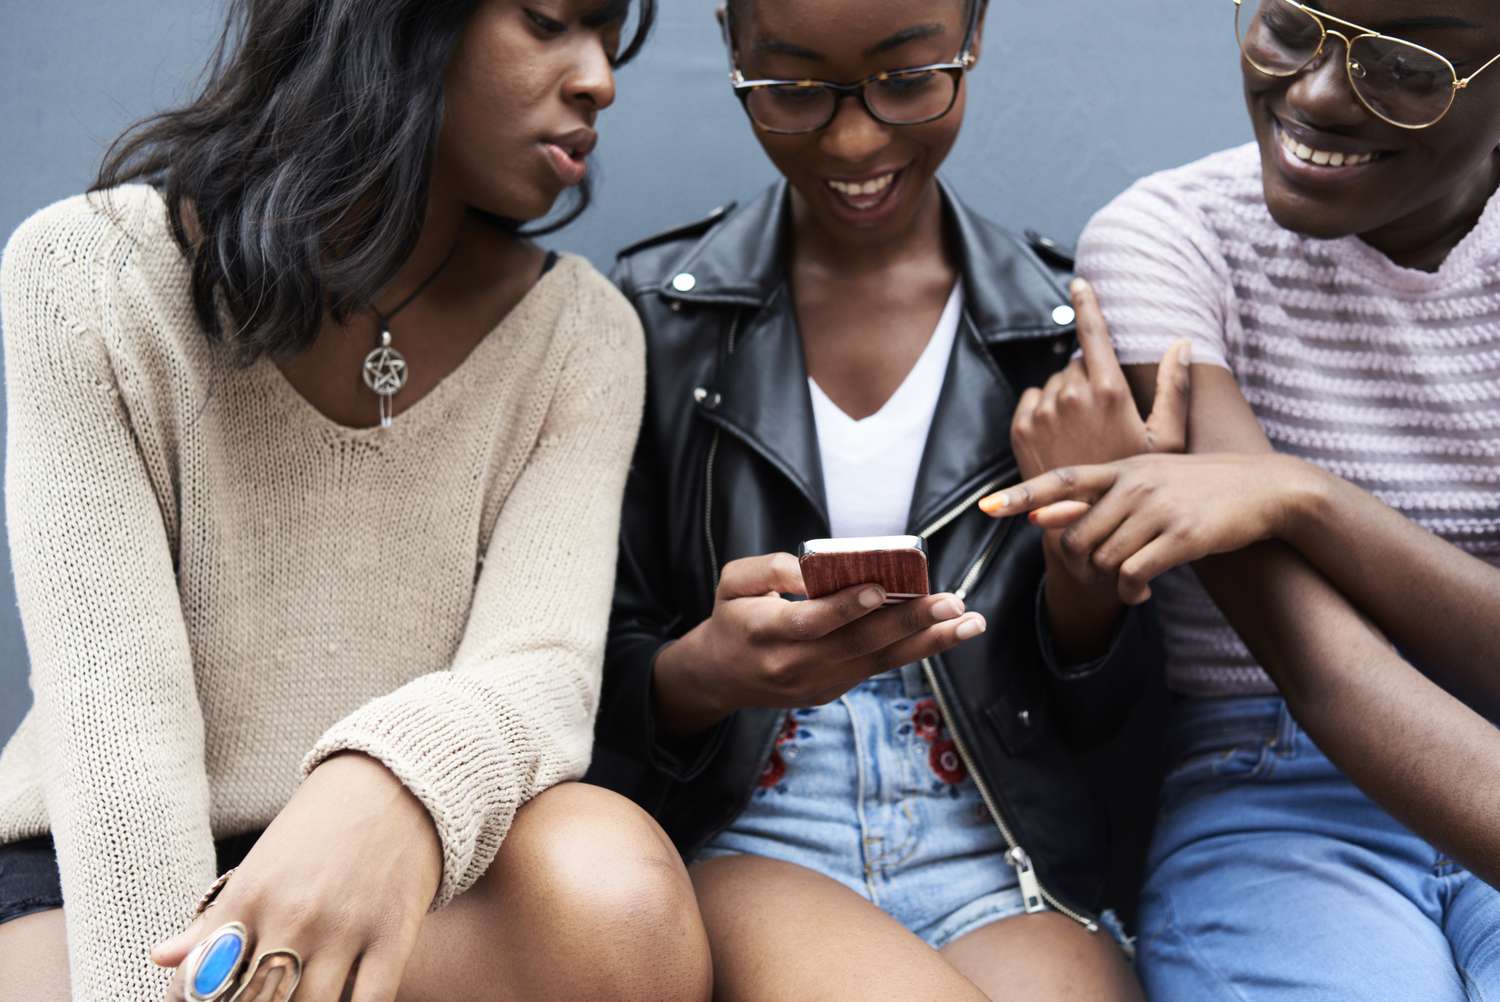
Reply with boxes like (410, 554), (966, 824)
(401, 783), (713, 1002)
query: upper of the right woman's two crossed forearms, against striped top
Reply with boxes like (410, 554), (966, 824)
(1283, 461), (1500, 717)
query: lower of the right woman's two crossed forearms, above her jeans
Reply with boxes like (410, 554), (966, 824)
(1196, 543), (1500, 884)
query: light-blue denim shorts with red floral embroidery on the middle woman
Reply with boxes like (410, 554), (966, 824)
(698, 665), (1026, 950)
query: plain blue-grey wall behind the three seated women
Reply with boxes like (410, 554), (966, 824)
(0, 0), (1250, 741)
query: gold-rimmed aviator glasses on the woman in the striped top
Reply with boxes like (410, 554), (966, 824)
(1235, 0), (1500, 129)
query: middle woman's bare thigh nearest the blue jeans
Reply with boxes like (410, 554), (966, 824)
(942, 912), (1146, 1002)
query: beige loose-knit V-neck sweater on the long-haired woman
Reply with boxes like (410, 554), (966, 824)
(0, 186), (645, 1002)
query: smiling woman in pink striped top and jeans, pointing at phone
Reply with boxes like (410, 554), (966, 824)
(986, 0), (1500, 1002)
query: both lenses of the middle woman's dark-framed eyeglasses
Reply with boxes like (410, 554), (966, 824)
(746, 69), (959, 132)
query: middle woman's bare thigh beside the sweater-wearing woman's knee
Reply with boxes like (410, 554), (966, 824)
(692, 857), (984, 1002)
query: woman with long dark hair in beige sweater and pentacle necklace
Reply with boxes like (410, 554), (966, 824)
(0, 0), (710, 1002)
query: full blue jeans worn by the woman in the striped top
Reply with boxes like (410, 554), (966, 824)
(1137, 698), (1500, 1002)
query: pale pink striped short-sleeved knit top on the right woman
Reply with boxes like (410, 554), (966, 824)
(1079, 146), (1500, 696)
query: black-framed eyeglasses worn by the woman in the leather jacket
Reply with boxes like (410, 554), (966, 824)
(725, 0), (983, 135)
